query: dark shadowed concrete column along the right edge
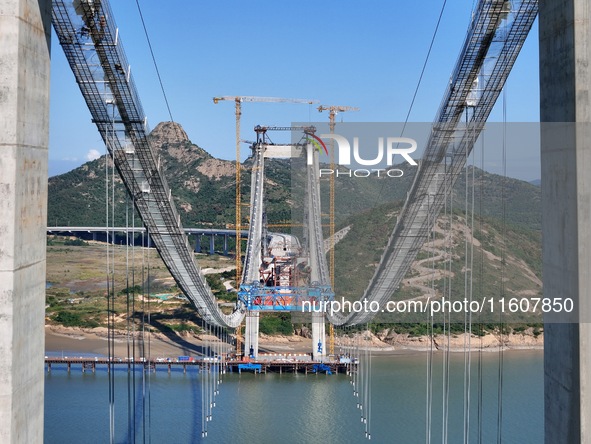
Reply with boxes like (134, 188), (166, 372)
(539, 0), (591, 444)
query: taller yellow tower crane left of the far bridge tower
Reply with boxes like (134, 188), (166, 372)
(213, 96), (318, 355)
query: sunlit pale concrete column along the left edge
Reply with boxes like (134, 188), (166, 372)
(0, 0), (51, 443)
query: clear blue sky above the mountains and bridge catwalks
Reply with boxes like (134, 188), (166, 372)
(49, 0), (540, 180)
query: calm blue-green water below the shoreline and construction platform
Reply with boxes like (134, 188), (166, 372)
(45, 351), (544, 444)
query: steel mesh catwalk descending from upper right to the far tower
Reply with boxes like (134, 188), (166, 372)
(329, 0), (538, 325)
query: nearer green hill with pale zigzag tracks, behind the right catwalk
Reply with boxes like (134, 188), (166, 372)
(335, 203), (542, 321)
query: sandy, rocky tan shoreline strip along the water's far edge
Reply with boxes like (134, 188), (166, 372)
(45, 325), (544, 358)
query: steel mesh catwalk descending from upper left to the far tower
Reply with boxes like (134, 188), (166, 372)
(52, 0), (244, 327)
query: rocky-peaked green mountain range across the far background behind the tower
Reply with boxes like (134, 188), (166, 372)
(47, 122), (540, 230)
